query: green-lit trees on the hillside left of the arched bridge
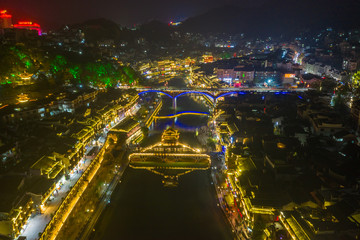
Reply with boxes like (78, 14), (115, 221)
(0, 44), (141, 87)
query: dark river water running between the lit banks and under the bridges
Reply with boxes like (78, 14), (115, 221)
(91, 80), (234, 240)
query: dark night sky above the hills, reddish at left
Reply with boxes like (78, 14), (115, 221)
(0, 0), (264, 28)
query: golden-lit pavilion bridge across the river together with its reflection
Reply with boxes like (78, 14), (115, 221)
(129, 128), (211, 186)
